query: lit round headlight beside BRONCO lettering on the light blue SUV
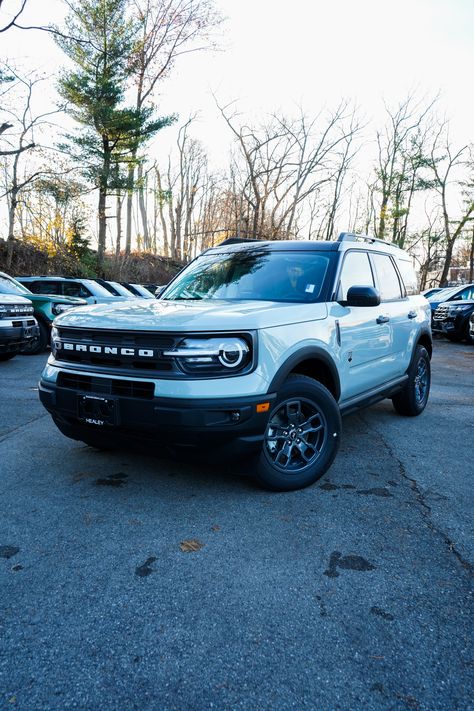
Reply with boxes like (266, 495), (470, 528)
(163, 336), (251, 375)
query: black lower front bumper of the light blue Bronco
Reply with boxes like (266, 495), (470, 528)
(39, 380), (276, 451)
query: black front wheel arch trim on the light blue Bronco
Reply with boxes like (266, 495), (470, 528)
(269, 346), (341, 402)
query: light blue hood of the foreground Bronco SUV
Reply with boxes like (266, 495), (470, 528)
(55, 299), (327, 331)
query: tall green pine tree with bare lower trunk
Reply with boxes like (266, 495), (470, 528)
(58, 0), (172, 269)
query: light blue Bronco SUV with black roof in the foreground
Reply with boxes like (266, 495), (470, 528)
(40, 233), (432, 491)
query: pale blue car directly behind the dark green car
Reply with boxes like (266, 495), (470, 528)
(18, 276), (130, 304)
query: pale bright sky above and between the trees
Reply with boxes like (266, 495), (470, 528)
(0, 0), (474, 232)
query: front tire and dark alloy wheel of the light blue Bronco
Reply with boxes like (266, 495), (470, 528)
(256, 375), (341, 491)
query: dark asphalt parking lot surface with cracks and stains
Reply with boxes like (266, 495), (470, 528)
(0, 340), (474, 711)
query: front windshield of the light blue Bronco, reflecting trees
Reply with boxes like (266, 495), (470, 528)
(161, 250), (330, 302)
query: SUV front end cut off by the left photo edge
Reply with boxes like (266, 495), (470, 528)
(0, 294), (39, 361)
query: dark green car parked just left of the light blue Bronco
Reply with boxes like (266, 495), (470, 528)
(0, 272), (87, 355)
